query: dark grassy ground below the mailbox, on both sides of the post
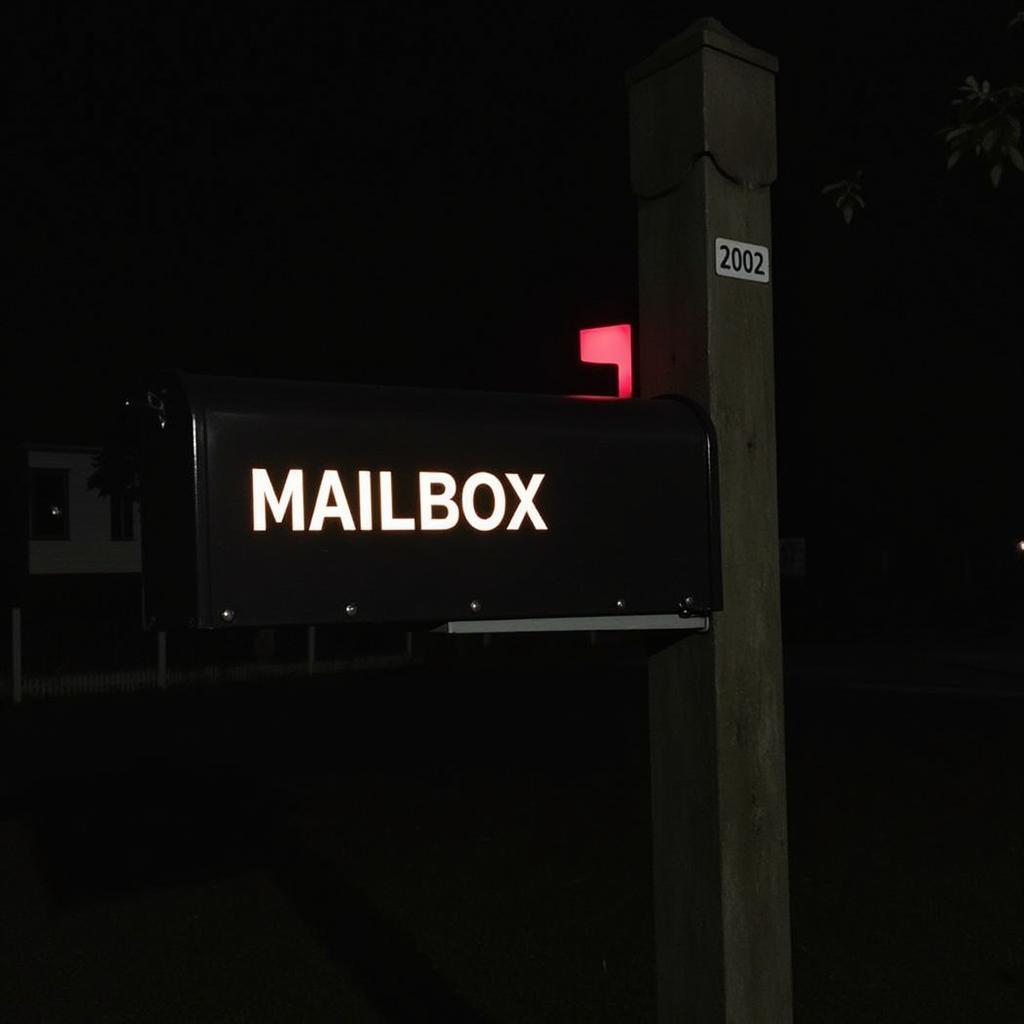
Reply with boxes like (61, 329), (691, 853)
(0, 647), (1024, 1024)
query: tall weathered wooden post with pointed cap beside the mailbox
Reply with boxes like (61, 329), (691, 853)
(629, 18), (793, 1024)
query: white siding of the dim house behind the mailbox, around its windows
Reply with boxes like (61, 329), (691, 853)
(29, 449), (141, 574)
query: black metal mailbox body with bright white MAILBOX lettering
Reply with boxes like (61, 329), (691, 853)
(142, 375), (721, 629)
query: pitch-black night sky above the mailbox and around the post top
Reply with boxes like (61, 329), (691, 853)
(4, 0), (1024, 569)
